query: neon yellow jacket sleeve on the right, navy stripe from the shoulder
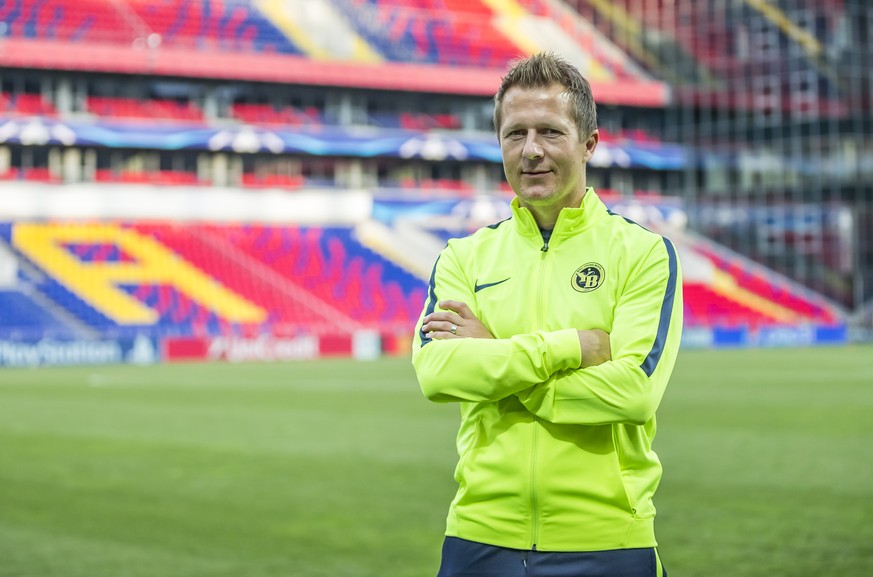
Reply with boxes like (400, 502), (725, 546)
(517, 239), (683, 425)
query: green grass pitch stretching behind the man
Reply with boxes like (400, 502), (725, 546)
(0, 347), (873, 577)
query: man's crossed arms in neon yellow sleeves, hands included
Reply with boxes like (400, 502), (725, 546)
(413, 241), (682, 425)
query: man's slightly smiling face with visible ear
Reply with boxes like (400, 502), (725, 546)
(498, 84), (598, 210)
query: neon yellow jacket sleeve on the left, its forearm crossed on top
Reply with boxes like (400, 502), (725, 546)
(412, 242), (581, 402)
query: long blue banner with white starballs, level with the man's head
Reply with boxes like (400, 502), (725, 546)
(0, 115), (690, 170)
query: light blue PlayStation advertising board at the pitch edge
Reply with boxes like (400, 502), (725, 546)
(0, 335), (160, 367)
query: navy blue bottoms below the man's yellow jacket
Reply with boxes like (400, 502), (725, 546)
(437, 537), (667, 577)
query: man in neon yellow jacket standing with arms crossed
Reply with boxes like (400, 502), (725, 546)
(413, 54), (682, 577)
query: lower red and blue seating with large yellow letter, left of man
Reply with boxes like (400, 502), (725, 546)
(0, 223), (424, 336)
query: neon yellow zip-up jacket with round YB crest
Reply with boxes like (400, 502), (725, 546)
(412, 188), (682, 551)
